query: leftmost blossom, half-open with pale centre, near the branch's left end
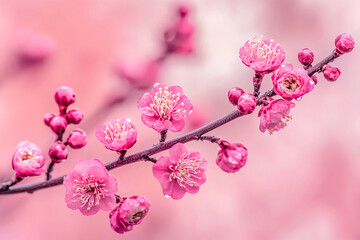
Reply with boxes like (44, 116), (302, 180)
(12, 141), (45, 177)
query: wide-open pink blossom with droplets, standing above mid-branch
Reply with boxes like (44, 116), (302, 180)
(138, 84), (193, 132)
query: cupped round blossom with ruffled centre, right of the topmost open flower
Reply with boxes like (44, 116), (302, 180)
(271, 64), (315, 100)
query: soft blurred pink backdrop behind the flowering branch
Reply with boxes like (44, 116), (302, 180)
(0, 0), (360, 240)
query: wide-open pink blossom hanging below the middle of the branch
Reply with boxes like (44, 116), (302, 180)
(153, 143), (207, 199)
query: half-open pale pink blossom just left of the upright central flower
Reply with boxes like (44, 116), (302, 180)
(95, 119), (137, 152)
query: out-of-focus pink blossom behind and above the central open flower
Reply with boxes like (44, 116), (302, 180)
(115, 58), (160, 89)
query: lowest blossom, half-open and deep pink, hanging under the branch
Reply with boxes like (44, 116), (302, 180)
(109, 196), (150, 233)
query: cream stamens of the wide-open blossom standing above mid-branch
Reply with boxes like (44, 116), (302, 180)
(150, 87), (186, 120)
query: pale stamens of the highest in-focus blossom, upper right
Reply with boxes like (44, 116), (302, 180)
(247, 39), (280, 63)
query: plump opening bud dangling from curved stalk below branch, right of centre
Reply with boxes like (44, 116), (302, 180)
(216, 141), (247, 173)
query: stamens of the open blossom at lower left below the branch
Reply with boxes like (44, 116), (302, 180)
(73, 174), (108, 210)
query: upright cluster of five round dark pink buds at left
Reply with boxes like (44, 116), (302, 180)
(44, 86), (87, 163)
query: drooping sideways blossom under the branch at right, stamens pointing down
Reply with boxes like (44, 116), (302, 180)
(259, 99), (295, 134)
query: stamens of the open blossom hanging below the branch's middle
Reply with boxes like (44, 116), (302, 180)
(169, 153), (202, 187)
